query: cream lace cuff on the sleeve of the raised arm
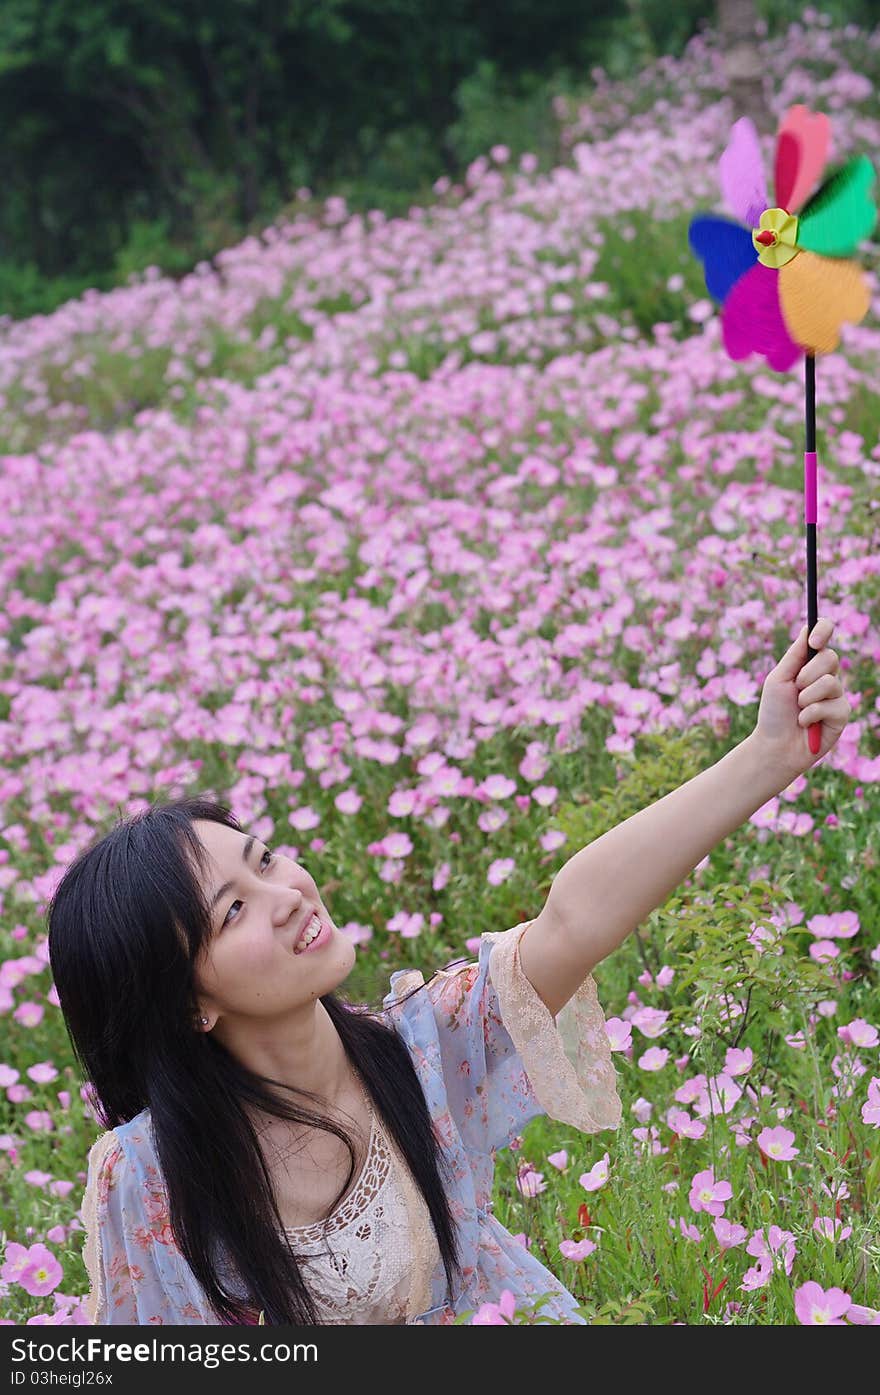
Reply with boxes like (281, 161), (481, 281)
(484, 921), (621, 1133)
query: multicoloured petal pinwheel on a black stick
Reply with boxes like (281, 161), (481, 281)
(688, 106), (877, 753)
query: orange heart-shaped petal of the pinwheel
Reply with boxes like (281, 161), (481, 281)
(780, 251), (870, 353)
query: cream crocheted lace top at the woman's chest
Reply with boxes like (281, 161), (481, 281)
(277, 1093), (441, 1325)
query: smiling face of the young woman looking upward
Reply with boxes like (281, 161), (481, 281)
(192, 819), (356, 1027)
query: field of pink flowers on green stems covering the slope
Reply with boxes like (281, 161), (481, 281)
(0, 17), (880, 1325)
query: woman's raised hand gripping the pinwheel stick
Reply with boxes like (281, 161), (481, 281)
(753, 619), (852, 780)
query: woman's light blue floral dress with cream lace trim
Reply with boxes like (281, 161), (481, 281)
(82, 921), (621, 1325)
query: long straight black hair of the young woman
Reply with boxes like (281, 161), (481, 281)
(47, 797), (460, 1325)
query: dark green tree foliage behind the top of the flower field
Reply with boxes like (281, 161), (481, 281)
(0, 0), (879, 317)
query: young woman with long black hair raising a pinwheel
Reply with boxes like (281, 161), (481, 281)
(49, 621), (851, 1325)
